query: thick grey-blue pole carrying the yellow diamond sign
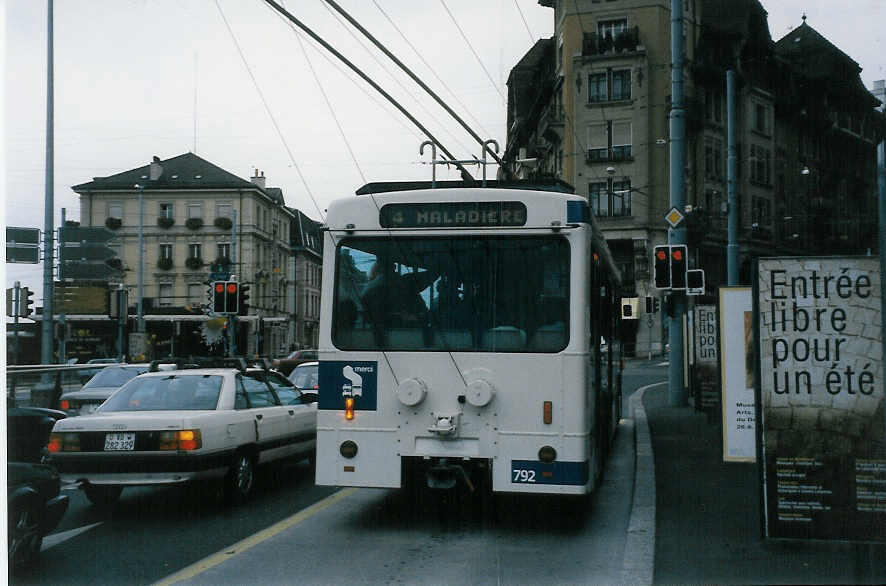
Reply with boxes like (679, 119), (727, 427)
(668, 0), (687, 407)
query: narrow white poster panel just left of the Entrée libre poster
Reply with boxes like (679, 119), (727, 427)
(720, 287), (757, 462)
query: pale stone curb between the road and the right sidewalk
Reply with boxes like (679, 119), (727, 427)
(621, 381), (667, 584)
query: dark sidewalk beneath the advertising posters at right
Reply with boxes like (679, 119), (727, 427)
(634, 385), (886, 584)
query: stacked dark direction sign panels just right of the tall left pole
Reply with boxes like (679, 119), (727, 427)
(59, 226), (119, 280)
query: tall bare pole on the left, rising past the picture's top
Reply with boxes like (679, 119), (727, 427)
(40, 0), (55, 364)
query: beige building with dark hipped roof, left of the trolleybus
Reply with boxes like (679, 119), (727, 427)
(72, 153), (295, 357)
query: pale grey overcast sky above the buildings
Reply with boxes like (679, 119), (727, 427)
(0, 0), (886, 305)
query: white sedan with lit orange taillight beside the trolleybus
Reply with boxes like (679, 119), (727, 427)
(48, 358), (317, 505)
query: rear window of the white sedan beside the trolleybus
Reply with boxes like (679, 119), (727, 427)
(99, 374), (224, 413)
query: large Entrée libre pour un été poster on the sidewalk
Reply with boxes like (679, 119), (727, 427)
(755, 257), (886, 541)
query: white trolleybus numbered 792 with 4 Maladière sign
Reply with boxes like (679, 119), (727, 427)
(316, 182), (621, 495)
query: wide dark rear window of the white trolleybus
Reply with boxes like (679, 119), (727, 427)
(332, 235), (569, 352)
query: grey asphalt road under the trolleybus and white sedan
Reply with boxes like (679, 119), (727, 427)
(11, 360), (666, 584)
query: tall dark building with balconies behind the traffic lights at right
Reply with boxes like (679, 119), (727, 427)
(505, 0), (884, 354)
